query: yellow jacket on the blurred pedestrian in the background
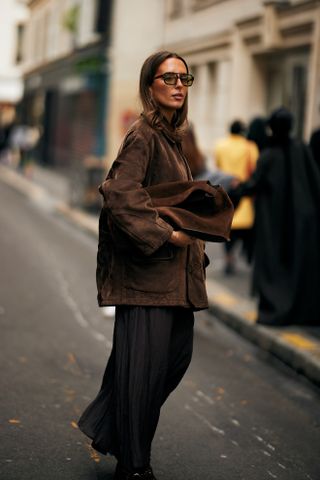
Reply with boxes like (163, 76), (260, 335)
(214, 134), (259, 229)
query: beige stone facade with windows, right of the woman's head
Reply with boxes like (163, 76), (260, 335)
(163, 0), (320, 153)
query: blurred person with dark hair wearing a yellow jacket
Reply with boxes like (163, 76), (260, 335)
(214, 120), (259, 274)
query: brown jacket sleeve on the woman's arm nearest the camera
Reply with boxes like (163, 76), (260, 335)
(100, 127), (173, 255)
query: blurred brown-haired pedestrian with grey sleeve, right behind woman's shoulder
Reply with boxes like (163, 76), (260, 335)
(182, 123), (235, 190)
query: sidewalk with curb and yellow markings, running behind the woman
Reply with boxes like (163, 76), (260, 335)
(0, 165), (320, 385)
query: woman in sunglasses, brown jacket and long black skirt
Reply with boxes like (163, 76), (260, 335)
(79, 52), (207, 480)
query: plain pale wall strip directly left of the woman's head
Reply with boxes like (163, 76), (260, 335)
(107, 0), (164, 165)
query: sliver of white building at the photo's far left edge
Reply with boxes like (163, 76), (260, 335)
(0, 0), (28, 126)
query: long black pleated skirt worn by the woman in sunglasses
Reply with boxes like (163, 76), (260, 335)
(78, 306), (194, 470)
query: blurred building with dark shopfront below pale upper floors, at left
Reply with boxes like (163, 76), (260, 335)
(22, 0), (111, 171)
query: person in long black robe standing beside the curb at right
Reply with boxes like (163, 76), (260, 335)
(233, 108), (320, 326)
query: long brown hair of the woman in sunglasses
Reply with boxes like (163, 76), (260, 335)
(139, 51), (189, 137)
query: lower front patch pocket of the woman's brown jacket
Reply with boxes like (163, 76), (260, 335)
(124, 244), (181, 294)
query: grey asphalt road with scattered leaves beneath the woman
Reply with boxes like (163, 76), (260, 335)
(0, 182), (320, 480)
